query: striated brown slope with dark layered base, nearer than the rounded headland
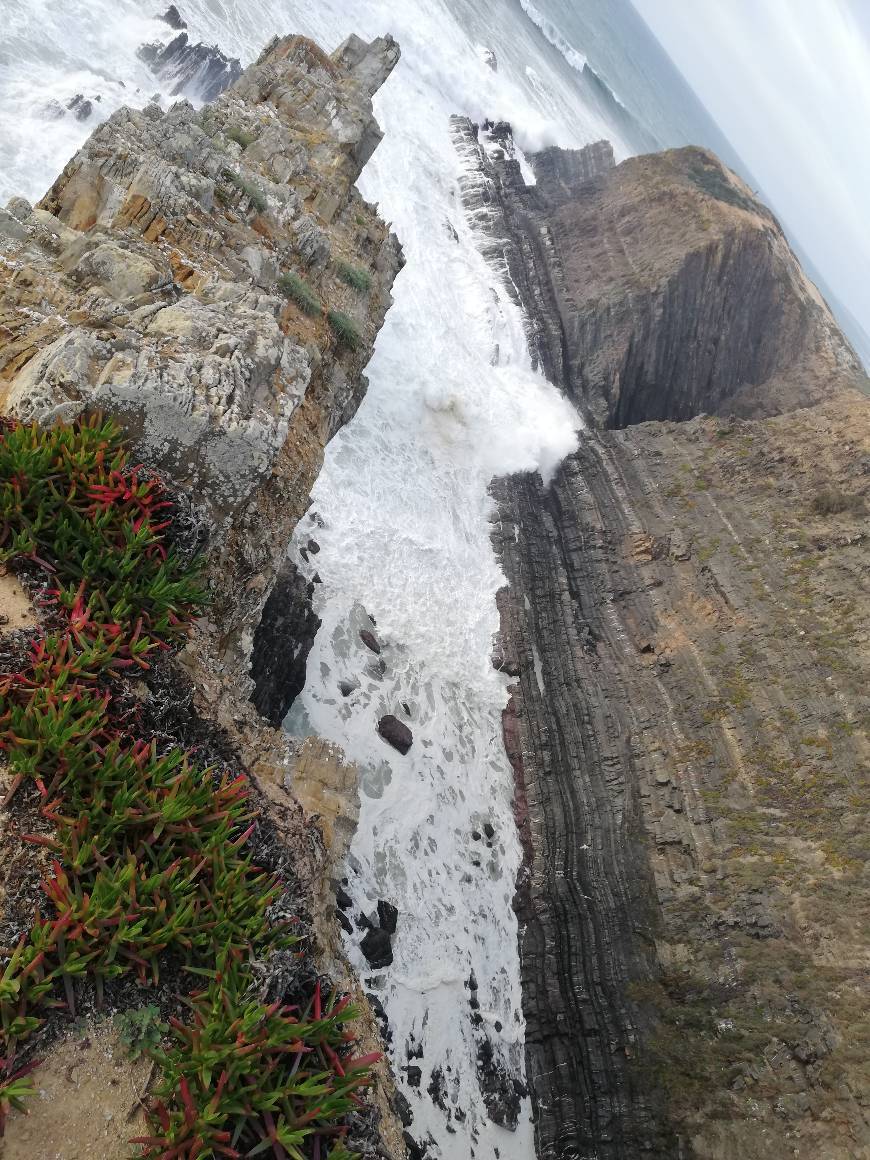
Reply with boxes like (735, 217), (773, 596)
(495, 393), (870, 1160)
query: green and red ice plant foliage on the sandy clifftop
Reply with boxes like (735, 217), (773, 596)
(0, 420), (377, 1160)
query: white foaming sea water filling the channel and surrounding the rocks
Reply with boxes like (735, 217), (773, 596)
(0, 0), (737, 1160)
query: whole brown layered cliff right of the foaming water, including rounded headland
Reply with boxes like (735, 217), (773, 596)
(455, 122), (870, 1160)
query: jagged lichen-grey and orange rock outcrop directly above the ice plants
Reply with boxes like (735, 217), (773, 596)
(0, 37), (401, 709)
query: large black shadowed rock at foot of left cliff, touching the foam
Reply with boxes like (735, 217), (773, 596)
(251, 560), (320, 726)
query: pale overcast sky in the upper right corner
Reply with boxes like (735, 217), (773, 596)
(633, 0), (870, 348)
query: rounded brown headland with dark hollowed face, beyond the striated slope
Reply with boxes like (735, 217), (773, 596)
(454, 118), (863, 427)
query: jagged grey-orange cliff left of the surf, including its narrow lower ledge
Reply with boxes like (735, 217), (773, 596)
(0, 27), (403, 1155)
